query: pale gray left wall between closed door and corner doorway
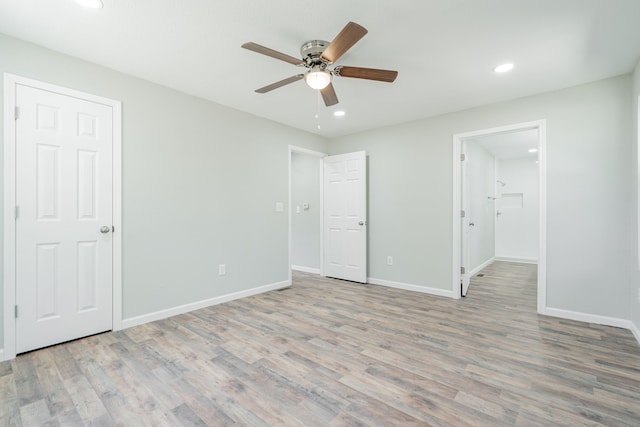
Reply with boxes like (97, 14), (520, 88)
(0, 35), (326, 348)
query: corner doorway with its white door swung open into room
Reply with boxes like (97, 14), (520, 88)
(288, 146), (367, 283)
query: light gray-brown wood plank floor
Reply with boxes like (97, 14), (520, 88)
(0, 262), (640, 426)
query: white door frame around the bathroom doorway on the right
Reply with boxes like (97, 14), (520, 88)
(451, 120), (547, 313)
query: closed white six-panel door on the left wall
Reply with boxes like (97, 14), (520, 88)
(16, 85), (113, 353)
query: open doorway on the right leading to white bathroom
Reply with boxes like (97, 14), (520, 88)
(453, 121), (546, 312)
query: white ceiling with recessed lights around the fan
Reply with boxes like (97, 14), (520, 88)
(0, 0), (640, 137)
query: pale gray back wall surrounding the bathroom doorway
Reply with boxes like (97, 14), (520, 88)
(329, 75), (632, 319)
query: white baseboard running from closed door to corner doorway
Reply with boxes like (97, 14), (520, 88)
(122, 280), (291, 329)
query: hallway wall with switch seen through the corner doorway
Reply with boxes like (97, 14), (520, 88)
(291, 152), (320, 270)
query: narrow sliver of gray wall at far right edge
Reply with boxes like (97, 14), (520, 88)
(629, 62), (640, 339)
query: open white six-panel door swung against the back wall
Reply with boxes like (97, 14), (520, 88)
(323, 151), (367, 283)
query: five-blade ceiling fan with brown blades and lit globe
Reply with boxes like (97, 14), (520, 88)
(242, 22), (398, 107)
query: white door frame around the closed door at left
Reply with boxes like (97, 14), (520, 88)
(0, 73), (122, 360)
